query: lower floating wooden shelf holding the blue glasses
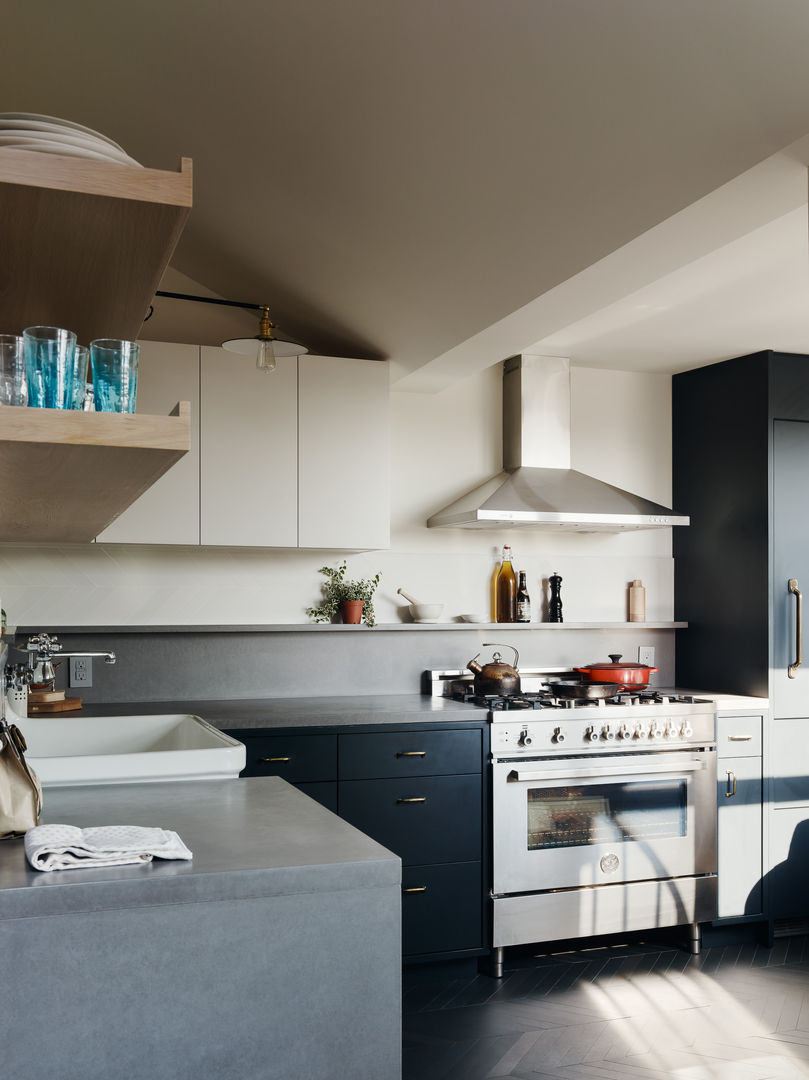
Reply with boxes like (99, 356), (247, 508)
(0, 402), (191, 542)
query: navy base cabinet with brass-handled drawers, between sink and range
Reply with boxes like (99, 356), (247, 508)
(229, 724), (488, 961)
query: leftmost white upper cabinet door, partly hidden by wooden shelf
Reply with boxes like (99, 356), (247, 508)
(95, 341), (200, 544)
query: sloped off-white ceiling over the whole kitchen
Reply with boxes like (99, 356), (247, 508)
(0, 0), (809, 391)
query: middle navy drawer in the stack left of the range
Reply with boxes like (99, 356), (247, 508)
(338, 775), (482, 865)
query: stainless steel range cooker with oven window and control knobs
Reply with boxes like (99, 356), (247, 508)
(426, 670), (716, 975)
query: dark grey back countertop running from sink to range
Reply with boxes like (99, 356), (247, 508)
(72, 693), (477, 730)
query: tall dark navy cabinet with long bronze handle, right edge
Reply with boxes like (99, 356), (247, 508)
(673, 351), (809, 919)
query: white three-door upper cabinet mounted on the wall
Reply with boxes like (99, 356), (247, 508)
(97, 341), (390, 551)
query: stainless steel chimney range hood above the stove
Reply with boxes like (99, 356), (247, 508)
(427, 355), (689, 532)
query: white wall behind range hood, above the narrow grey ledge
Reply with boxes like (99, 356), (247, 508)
(0, 365), (673, 629)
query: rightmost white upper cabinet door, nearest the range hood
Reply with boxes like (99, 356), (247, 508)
(298, 356), (390, 549)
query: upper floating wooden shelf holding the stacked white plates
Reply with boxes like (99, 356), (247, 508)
(0, 148), (191, 345)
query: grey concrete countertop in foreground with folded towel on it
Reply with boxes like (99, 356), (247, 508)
(0, 777), (401, 921)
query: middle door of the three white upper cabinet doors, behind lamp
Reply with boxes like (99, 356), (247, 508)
(200, 347), (298, 548)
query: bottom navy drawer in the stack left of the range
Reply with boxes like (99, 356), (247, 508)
(402, 863), (483, 957)
